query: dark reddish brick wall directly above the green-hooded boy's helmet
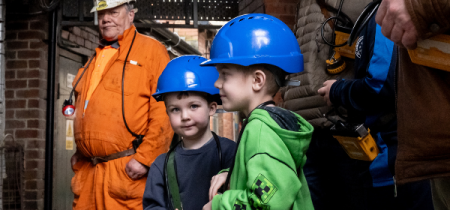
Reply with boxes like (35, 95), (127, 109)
(239, 0), (298, 28)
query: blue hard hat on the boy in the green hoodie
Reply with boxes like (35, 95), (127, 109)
(202, 14), (303, 73)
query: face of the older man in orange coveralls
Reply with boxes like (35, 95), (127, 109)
(98, 5), (134, 41)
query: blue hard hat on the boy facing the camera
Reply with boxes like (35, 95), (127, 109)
(153, 55), (220, 104)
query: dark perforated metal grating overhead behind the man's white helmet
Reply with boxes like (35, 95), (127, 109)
(62, 0), (243, 21)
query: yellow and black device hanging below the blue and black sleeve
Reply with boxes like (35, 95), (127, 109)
(330, 121), (380, 161)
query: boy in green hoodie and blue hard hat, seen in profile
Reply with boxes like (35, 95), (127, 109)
(202, 14), (314, 210)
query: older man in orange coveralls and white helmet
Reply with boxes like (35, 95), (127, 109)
(71, 0), (173, 210)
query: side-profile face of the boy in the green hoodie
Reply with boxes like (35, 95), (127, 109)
(214, 64), (252, 111)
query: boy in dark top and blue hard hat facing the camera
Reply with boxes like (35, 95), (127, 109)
(143, 56), (236, 210)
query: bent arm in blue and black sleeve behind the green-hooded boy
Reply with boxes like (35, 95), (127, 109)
(325, 26), (395, 114)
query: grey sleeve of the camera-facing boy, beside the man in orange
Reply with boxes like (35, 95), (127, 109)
(142, 155), (167, 210)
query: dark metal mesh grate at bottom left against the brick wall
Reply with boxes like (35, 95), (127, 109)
(0, 146), (24, 210)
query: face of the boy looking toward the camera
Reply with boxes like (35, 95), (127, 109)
(164, 92), (217, 140)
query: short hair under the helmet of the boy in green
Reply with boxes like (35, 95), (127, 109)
(237, 64), (287, 96)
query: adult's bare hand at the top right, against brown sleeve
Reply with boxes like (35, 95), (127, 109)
(375, 0), (419, 49)
